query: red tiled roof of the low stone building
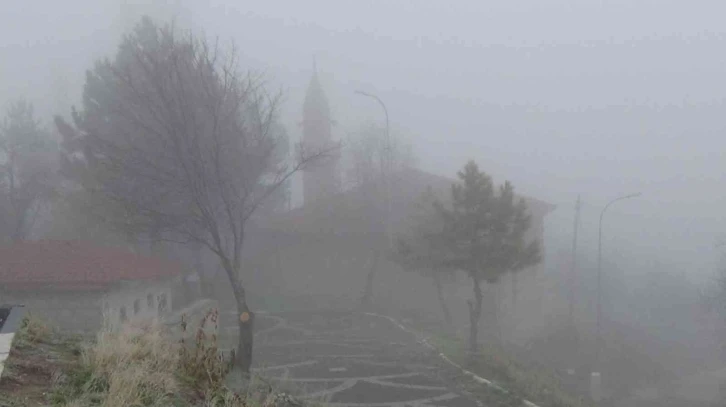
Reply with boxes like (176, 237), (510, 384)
(0, 240), (182, 290)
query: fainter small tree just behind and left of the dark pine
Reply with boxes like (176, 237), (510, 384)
(392, 188), (456, 326)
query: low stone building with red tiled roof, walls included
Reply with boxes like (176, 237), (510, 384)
(0, 240), (182, 332)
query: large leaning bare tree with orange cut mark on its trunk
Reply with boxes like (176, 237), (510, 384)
(57, 18), (325, 372)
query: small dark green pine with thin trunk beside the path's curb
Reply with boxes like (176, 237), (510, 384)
(435, 161), (541, 352)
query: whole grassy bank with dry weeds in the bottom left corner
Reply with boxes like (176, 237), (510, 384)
(0, 314), (304, 407)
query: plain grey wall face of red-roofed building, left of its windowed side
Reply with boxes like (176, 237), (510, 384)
(0, 291), (102, 332)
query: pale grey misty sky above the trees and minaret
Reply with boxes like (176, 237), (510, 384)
(0, 0), (726, 280)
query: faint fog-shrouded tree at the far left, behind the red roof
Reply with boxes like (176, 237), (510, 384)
(0, 100), (58, 242)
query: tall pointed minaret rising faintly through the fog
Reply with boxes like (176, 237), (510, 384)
(302, 60), (340, 205)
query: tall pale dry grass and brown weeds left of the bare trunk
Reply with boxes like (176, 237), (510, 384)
(50, 310), (302, 407)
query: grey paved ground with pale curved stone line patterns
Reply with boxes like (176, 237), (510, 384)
(222, 312), (478, 407)
